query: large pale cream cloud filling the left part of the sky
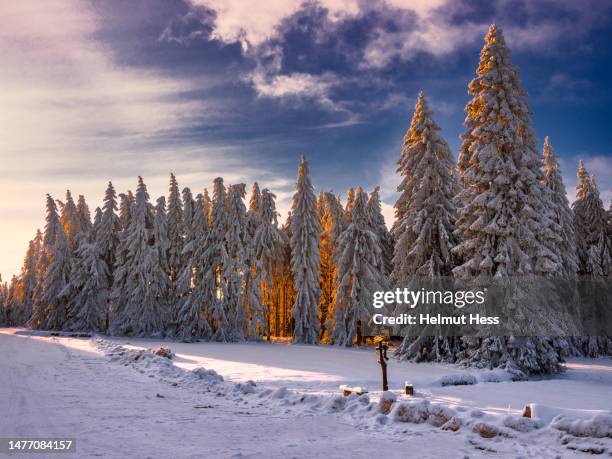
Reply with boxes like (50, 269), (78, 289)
(0, 0), (284, 277)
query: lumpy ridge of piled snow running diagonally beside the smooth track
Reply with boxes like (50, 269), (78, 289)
(94, 338), (612, 453)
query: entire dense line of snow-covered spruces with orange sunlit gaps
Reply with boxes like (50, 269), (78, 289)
(0, 26), (612, 373)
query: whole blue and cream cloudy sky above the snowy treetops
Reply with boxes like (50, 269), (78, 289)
(0, 0), (612, 280)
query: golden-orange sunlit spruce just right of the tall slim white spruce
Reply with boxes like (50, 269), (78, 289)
(317, 190), (346, 342)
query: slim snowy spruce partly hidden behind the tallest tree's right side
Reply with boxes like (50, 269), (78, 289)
(543, 137), (578, 276)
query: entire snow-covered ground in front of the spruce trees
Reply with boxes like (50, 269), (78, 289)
(0, 329), (612, 458)
